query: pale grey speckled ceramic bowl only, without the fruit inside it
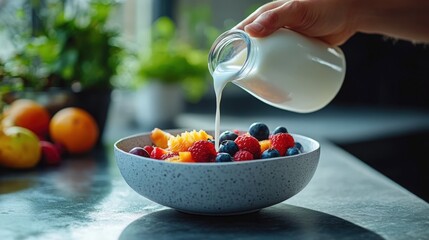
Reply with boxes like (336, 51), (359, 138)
(114, 130), (320, 215)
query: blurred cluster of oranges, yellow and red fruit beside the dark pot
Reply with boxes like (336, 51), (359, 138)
(0, 98), (99, 169)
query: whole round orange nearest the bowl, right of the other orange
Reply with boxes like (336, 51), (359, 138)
(49, 107), (99, 154)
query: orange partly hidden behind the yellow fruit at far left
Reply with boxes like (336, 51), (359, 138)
(2, 99), (51, 136)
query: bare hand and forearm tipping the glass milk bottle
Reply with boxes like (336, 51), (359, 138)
(236, 0), (429, 45)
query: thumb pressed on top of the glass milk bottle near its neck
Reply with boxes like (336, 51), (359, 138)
(244, 1), (313, 37)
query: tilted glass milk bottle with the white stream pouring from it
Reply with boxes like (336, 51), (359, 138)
(208, 29), (345, 149)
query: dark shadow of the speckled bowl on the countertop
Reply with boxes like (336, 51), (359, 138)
(120, 206), (383, 239)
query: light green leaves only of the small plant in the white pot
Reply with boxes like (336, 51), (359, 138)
(135, 17), (208, 101)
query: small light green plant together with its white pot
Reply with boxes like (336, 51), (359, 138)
(129, 17), (210, 129)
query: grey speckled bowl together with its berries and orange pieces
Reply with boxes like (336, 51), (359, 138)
(114, 123), (320, 215)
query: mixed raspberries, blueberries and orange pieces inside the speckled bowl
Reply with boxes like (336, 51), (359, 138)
(129, 122), (305, 163)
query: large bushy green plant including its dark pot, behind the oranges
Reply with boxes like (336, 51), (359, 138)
(0, 0), (123, 138)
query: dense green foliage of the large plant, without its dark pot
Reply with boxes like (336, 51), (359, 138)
(0, 1), (121, 91)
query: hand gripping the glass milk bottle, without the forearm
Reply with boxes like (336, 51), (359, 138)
(235, 0), (357, 45)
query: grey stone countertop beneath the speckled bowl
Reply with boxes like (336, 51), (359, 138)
(0, 105), (429, 240)
